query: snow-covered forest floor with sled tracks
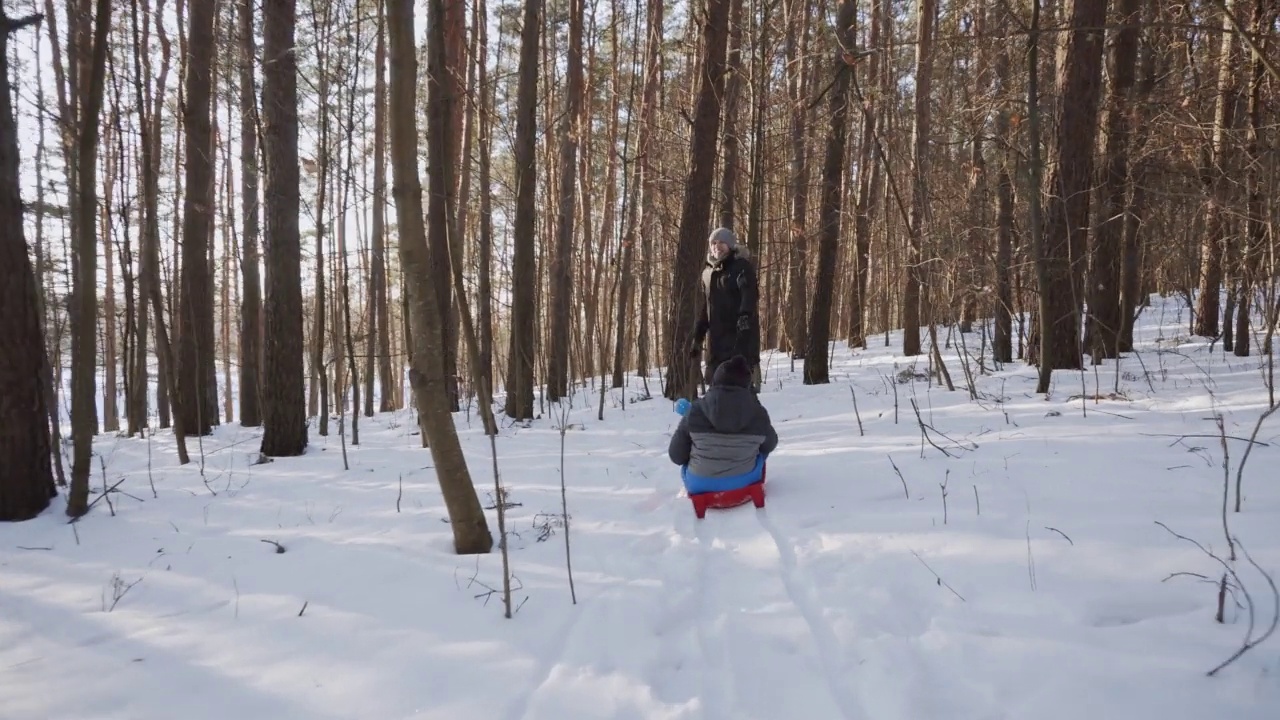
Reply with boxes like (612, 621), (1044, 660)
(0, 299), (1280, 720)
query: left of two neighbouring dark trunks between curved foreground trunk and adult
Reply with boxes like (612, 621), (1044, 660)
(506, 0), (543, 420)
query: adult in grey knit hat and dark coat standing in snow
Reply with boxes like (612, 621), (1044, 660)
(690, 228), (760, 392)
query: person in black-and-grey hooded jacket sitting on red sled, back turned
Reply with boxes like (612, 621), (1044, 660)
(667, 355), (778, 495)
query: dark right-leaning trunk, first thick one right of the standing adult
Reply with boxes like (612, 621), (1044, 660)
(804, 0), (855, 384)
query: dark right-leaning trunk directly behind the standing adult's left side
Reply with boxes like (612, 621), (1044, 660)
(664, 0), (730, 400)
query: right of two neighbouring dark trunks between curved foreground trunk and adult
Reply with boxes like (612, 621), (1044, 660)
(547, 0), (586, 402)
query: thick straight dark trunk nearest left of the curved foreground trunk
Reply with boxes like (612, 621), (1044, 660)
(262, 0), (307, 456)
